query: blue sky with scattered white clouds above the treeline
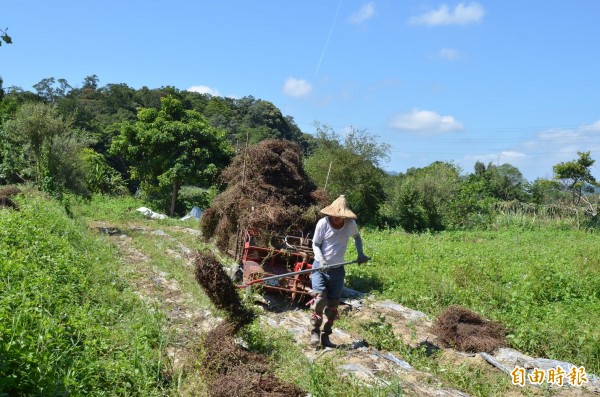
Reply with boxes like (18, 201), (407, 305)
(0, 0), (600, 181)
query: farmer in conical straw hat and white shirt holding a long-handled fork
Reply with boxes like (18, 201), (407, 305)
(310, 195), (369, 347)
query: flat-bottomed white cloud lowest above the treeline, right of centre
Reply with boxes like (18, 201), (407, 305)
(390, 109), (463, 132)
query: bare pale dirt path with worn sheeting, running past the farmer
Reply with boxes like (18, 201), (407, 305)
(90, 222), (600, 396)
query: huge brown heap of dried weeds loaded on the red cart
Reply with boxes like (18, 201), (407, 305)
(200, 139), (328, 252)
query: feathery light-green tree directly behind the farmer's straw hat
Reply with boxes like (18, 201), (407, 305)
(305, 125), (389, 225)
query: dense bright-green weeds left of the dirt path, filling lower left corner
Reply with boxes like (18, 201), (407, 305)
(0, 191), (170, 396)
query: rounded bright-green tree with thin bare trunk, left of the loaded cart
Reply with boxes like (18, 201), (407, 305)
(111, 96), (232, 216)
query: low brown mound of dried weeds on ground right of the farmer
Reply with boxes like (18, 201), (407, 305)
(432, 306), (506, 353)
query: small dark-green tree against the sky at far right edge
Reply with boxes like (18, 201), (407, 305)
(552, 152), (600, 209)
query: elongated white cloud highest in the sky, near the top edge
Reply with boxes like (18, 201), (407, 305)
(409, 3), (485, 26)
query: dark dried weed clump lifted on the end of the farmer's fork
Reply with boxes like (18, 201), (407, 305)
(195, 253), (254, 330)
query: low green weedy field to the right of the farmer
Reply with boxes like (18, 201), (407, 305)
(348, 225), (600, 374)
